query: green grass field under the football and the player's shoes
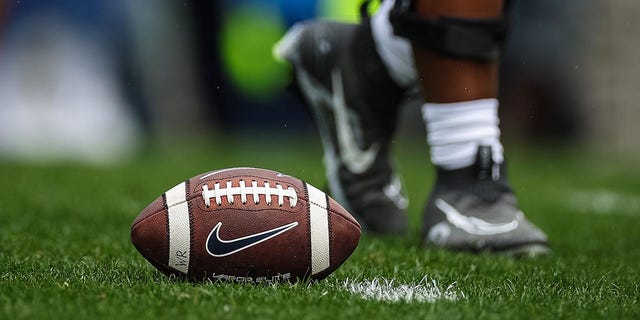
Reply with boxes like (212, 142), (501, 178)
(0, 138), (640, 320)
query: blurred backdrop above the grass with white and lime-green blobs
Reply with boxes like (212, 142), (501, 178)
(0, 0), (640, 163)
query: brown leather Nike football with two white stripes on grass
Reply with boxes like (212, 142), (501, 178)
(131, 168), (361, 283)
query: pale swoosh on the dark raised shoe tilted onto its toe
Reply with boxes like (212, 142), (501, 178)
(331, 69), (380, 174)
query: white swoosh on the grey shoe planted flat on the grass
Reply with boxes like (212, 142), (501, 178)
(435, 199), (520, 235)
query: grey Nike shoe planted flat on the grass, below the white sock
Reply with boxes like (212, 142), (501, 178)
(422, 147), (549, 256)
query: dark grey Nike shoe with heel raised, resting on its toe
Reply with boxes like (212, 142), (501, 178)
(274, 20), (407, 234)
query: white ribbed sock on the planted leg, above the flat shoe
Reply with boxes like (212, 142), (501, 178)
(422, 99), (503, 170)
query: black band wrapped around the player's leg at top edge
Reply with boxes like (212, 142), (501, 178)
(389, 0), (511, 61)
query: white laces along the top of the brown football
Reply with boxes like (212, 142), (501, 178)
(202, 180), (298, 208)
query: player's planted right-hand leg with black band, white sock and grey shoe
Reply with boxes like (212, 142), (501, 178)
(373, 0), (547, 254)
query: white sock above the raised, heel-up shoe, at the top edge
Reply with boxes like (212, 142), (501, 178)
(371, 0), (418, 87)
